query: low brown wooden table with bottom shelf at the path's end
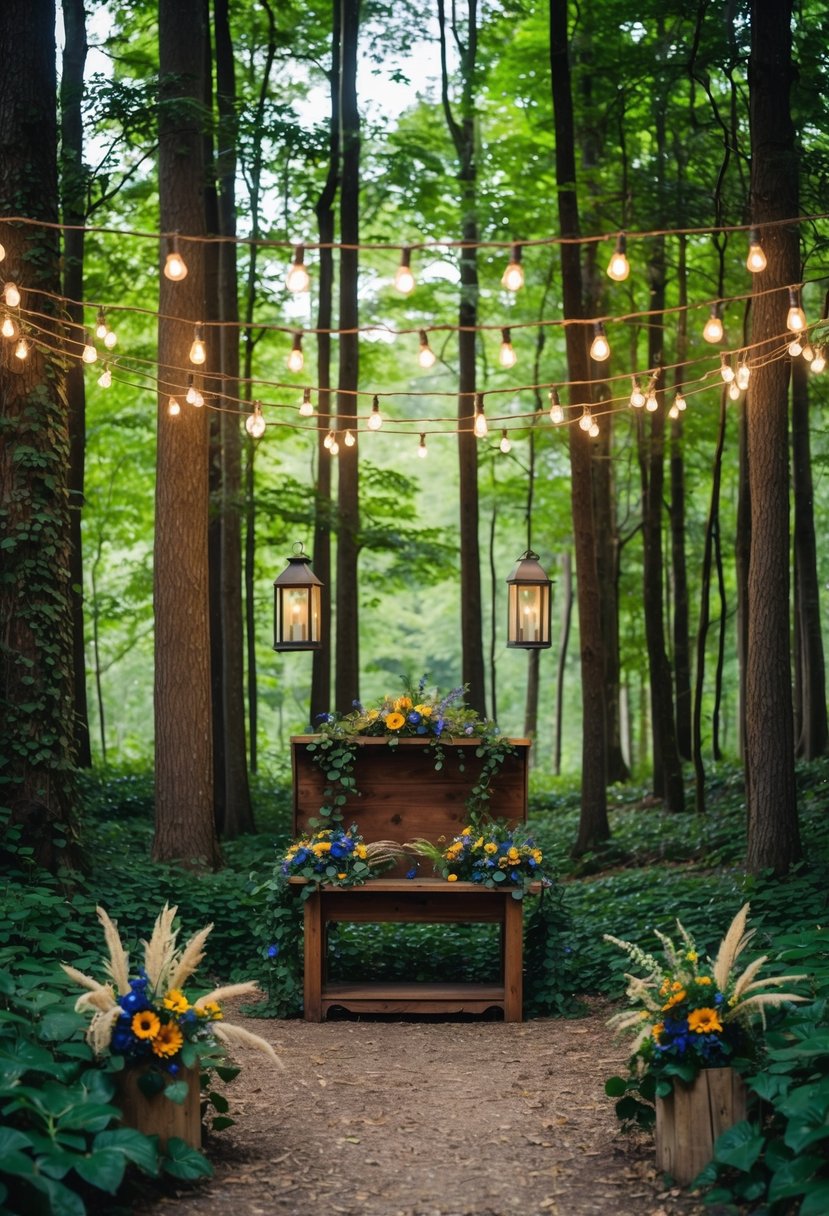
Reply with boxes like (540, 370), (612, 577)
(291, 878), (524, 1021)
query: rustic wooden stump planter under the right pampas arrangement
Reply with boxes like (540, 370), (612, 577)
(656, 1068), (746, 1187)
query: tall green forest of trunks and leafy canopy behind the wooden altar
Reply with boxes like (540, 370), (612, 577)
(0, 0), (829, 1214)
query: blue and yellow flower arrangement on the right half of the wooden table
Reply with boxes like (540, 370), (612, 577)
(407, 818), (549, 899)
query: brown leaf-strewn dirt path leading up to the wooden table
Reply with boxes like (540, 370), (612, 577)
(132, 1002), (716, 1216)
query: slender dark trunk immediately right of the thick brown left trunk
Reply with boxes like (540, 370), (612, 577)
(214, 0), (254, 839)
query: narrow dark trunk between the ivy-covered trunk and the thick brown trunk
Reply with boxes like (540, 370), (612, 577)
(61, 0), (92, 769)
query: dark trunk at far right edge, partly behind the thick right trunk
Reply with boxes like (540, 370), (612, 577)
(791, 359), (829, 760)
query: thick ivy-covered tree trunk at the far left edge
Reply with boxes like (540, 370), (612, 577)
(0, 0), (80, 869)
